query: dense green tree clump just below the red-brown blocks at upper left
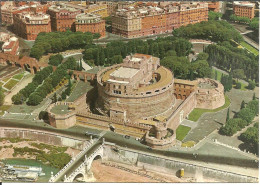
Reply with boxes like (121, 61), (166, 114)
(30, 31), (96, 60)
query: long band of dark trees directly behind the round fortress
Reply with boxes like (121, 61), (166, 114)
(83, 37), (192, 65)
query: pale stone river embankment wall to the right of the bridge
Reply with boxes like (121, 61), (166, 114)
(104, 145), (258, 182)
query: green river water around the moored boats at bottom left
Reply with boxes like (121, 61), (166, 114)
(2, 158), (59, 182)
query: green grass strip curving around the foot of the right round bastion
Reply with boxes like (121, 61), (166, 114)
(188, 95), (230, 122)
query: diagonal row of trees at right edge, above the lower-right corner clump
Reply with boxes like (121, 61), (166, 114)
(219, 100), (259, 136)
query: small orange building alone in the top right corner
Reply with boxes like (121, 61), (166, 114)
(233, 1), (255, 19)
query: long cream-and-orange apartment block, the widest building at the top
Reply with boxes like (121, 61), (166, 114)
(112, 2), (208, 38)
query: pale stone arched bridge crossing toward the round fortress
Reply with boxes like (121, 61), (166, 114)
(49, 131), (106, 182)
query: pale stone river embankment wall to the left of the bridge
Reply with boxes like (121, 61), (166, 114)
(0, 127), (85, 150)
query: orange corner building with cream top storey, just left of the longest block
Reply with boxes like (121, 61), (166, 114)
(75, 13), (106, 37)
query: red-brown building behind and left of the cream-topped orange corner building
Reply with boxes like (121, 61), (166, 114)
(47, 4), (81, 31)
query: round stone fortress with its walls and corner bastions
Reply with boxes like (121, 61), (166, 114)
(48, 54), (225, 148)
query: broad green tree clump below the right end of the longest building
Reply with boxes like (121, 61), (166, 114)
(173, 20), (243, 42)
